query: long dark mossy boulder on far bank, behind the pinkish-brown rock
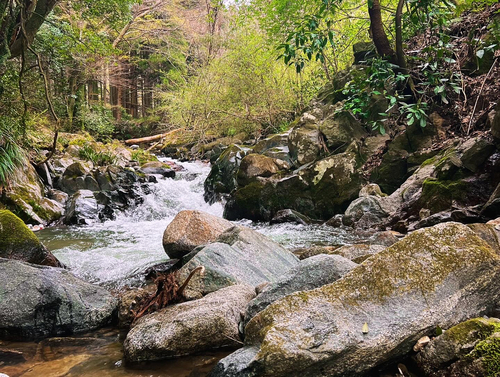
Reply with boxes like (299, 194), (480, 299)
(224, 143), (365, 221)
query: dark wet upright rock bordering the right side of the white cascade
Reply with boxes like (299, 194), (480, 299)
(204, 144), (249, 203)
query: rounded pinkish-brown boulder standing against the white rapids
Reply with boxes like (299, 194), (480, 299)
(163, 211), (233, 259)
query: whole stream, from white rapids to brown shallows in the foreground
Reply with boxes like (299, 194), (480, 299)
(0, 162), (368, 377)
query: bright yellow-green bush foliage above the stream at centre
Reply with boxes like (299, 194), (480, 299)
(162, 19), (312, 141)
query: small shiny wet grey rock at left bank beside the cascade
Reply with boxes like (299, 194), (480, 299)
(64, 190), (99, 225)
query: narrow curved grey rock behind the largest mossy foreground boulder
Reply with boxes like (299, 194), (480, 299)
(244, 254), (357, 325)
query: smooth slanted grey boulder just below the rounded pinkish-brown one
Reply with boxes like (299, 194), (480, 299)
(179, 226), (299, 297)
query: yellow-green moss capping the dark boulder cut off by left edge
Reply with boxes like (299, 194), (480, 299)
(0, 210), (40, 252)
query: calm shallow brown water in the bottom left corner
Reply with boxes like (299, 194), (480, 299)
(0, 329), (232, 377)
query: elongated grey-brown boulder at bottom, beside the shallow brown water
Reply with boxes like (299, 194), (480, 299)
(124, 285), (255, 362)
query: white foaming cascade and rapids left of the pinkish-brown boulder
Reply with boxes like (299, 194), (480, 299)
(39, 162), (223, 288)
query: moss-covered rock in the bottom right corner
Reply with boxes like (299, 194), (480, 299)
(416, 318), (500, 377)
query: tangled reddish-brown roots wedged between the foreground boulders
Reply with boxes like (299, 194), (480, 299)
(132, 266), (205, 325)
